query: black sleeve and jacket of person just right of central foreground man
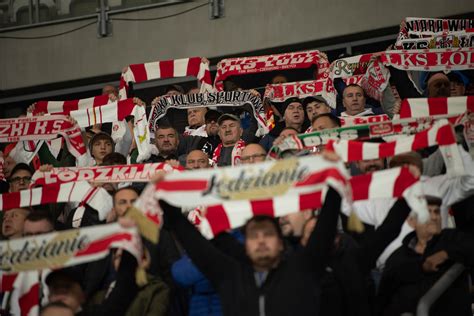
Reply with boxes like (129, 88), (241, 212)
(321, 199), (410, 316)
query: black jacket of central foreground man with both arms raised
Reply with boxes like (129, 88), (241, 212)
(161, 189), (341, 316)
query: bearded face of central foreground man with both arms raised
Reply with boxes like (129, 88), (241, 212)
(245, 221), (283, 271)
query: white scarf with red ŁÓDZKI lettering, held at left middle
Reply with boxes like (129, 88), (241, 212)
(32, 162), (184, 186)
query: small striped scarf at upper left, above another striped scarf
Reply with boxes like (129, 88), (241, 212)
(33, 95), (109, 115)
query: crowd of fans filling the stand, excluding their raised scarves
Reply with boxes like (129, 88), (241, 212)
(1, 16), (474, 316)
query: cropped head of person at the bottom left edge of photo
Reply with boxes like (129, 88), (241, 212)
(49, 280), (85, 312)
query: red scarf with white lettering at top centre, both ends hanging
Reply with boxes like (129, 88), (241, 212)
(214, 50), (329, 91)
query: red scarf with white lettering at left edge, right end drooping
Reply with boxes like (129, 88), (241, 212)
(0, 115), (87, 158)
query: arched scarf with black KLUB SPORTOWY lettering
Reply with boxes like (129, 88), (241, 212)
(149, 91), (268, 136)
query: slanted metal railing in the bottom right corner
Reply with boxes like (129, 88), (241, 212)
(416, 263), (465, 316)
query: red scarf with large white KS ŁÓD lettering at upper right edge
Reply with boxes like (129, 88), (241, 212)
(361, 48), (474, 100)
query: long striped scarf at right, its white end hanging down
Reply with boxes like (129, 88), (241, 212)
(326, 119), (464, 176)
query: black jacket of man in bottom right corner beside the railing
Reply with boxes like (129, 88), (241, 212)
(377, 229), (474, 316)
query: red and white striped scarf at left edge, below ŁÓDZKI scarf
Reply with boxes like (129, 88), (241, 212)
(0, 181), (113, 220)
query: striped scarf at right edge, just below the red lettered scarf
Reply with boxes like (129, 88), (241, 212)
(400, 96), (474, 119)
